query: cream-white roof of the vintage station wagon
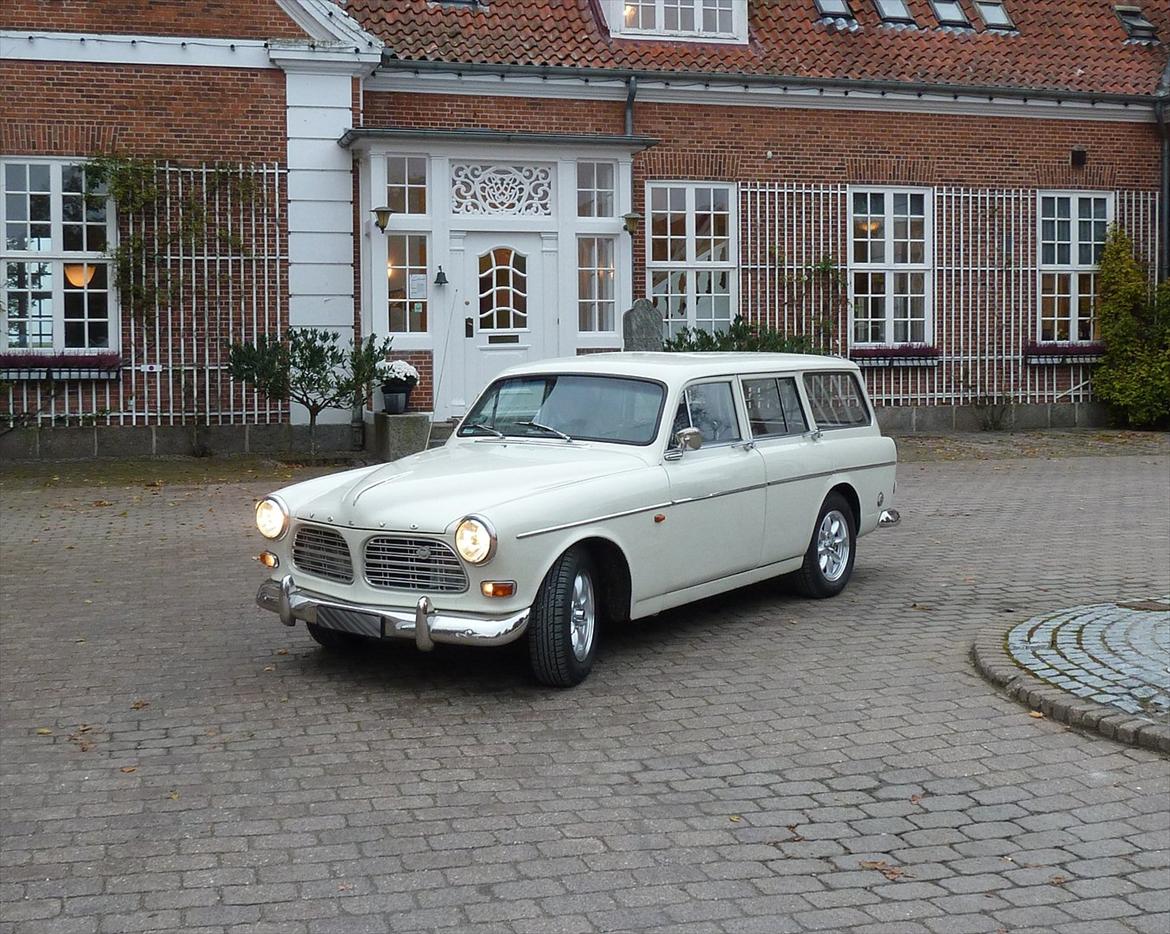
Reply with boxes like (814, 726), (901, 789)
(501, 351), (858, 384)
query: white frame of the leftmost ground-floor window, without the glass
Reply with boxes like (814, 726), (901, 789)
(0, 156), (122, 356)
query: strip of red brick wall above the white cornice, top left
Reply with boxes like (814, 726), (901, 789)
(0, 0), (304, 39)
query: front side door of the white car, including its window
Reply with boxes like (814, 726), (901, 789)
(661, 377), (766, 592)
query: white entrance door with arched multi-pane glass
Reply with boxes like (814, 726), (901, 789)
(462, 233), (557, 405)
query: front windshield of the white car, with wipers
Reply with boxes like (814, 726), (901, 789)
(459, 376), (665, 445)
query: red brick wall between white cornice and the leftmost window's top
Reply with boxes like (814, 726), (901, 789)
(0, 61), (285, 162)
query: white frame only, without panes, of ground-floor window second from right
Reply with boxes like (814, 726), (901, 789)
(846, 185), (935, 348)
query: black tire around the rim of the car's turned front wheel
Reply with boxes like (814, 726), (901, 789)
(528, 548), (601, 687)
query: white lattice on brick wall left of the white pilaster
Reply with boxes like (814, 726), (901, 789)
(0, 164), (288, 425)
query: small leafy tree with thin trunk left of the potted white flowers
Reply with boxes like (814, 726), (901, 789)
(228, 328), (390, 454)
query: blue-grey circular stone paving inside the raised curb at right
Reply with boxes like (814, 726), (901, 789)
(1007, 597), (1170, 723)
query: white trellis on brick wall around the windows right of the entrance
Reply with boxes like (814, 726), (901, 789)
(739, 183), (1158, 405)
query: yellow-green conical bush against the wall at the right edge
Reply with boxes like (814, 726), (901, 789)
(1093, 226), (1170, 427)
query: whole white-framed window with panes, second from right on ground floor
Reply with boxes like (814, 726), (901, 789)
(849, 188), (934, 346)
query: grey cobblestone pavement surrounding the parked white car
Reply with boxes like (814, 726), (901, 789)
(0, 454), (1170, 934)
